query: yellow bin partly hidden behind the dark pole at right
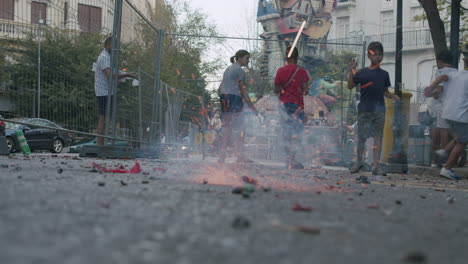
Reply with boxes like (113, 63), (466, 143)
(382, 91), (413, 162)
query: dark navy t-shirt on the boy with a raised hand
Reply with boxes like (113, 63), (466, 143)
(354, 67), (391, 112)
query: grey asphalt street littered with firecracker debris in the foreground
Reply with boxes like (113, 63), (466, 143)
(0, 154), (468, 264)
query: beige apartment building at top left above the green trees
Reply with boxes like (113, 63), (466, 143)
(0, 0), (158, 39)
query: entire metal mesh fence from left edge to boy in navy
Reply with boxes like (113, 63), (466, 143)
(0, 0), (365, 163)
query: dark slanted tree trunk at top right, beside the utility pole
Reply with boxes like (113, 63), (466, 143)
(418, 0), (448, 55)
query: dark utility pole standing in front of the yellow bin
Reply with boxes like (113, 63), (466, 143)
(389, 0), (408, 173)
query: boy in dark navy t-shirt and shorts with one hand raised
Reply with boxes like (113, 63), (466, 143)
(348, 42), (400, 176)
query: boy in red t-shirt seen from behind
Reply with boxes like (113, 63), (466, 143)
(274, 47), (310, 169)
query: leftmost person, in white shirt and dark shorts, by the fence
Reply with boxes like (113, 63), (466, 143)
(93, 37), (137, 145)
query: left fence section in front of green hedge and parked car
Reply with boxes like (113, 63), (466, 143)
(0, 0), (192, 148)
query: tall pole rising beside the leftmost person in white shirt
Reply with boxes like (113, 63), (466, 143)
(105, 0), (123, 144)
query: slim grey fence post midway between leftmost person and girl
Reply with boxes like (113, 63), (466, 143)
(151, 29), (164, 143)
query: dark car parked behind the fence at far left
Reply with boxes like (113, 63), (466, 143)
(5, 118), (72, 153)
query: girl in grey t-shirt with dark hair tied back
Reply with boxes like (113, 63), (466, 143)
(218, 50), (258, 163)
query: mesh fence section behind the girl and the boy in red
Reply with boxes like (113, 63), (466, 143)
(164, 30), (366, 163)
